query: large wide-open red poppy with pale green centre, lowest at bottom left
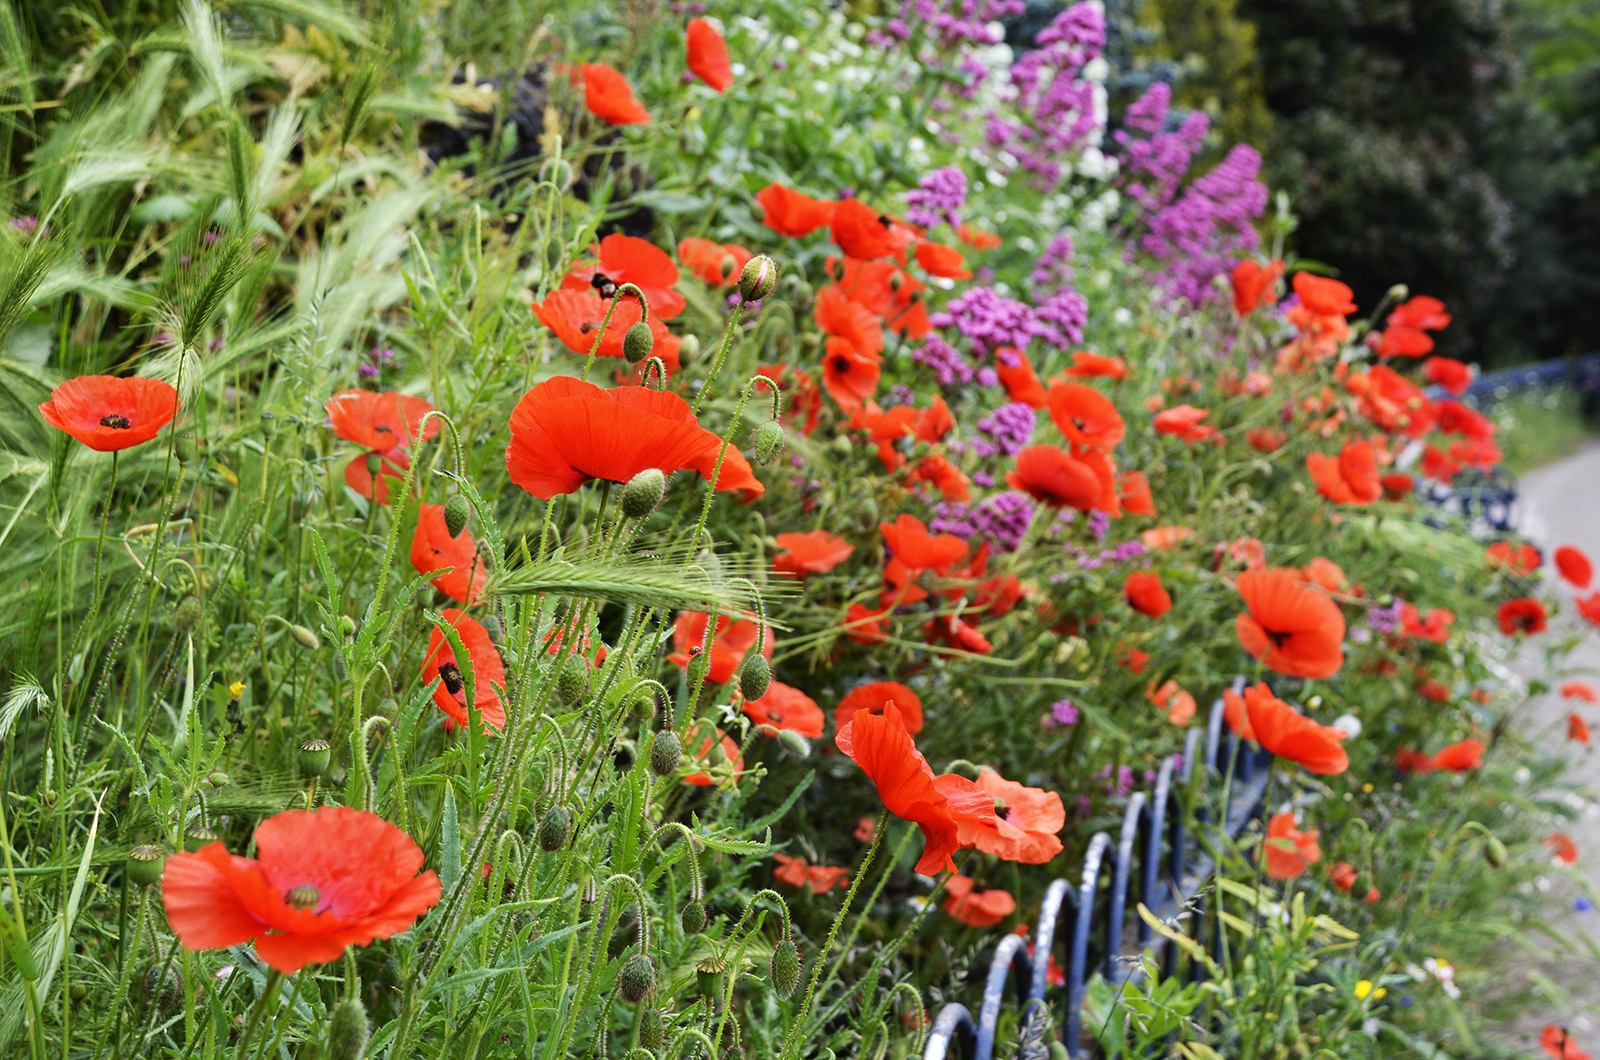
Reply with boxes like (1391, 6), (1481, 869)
(162, 805), (442, 975)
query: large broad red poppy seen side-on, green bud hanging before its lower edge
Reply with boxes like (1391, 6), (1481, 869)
(506, 376), (749, 500)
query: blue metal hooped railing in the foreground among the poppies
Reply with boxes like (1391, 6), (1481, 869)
(923, 679), (1272, 1060)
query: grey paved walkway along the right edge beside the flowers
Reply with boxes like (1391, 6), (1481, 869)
(1502, 442), (1600, 1054)
